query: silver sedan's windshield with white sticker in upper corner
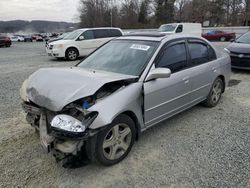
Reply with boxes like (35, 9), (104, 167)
(78, 40), (158, 76)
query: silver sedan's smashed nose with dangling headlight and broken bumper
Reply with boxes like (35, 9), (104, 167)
(22, 102), (100, 166)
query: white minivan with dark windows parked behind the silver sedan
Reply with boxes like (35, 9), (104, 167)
(46, 27), (123, 61)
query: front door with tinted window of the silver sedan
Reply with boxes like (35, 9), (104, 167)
(144, 40), (191, 126)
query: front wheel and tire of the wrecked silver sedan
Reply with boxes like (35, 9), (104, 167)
(95, 115), (136, 166)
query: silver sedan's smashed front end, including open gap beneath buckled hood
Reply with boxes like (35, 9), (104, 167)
(21, 74), (134, 166)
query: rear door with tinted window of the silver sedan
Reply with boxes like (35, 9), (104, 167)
(188, 39), (219, 103)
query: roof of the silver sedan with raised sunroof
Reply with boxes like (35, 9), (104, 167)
(116, 32), (207, 42)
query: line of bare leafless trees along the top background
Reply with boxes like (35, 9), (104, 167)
(79, 0), (250, 29)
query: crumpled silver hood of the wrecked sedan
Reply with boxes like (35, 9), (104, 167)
(26, 67), (136, 111)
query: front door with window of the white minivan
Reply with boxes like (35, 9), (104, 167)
(76, 30), (97, 56)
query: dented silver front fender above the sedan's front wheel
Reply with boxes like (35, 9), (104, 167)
(88, 82), (144, 129)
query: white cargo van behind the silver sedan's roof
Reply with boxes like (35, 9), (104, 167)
(158, 23), (202, 37)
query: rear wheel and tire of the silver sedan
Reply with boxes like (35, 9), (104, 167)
(203, 78), (224, 108)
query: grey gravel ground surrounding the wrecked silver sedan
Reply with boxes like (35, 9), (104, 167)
(0, 43), (250, 188)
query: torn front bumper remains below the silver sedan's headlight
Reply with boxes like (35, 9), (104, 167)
(22, 102), (100, 156)
